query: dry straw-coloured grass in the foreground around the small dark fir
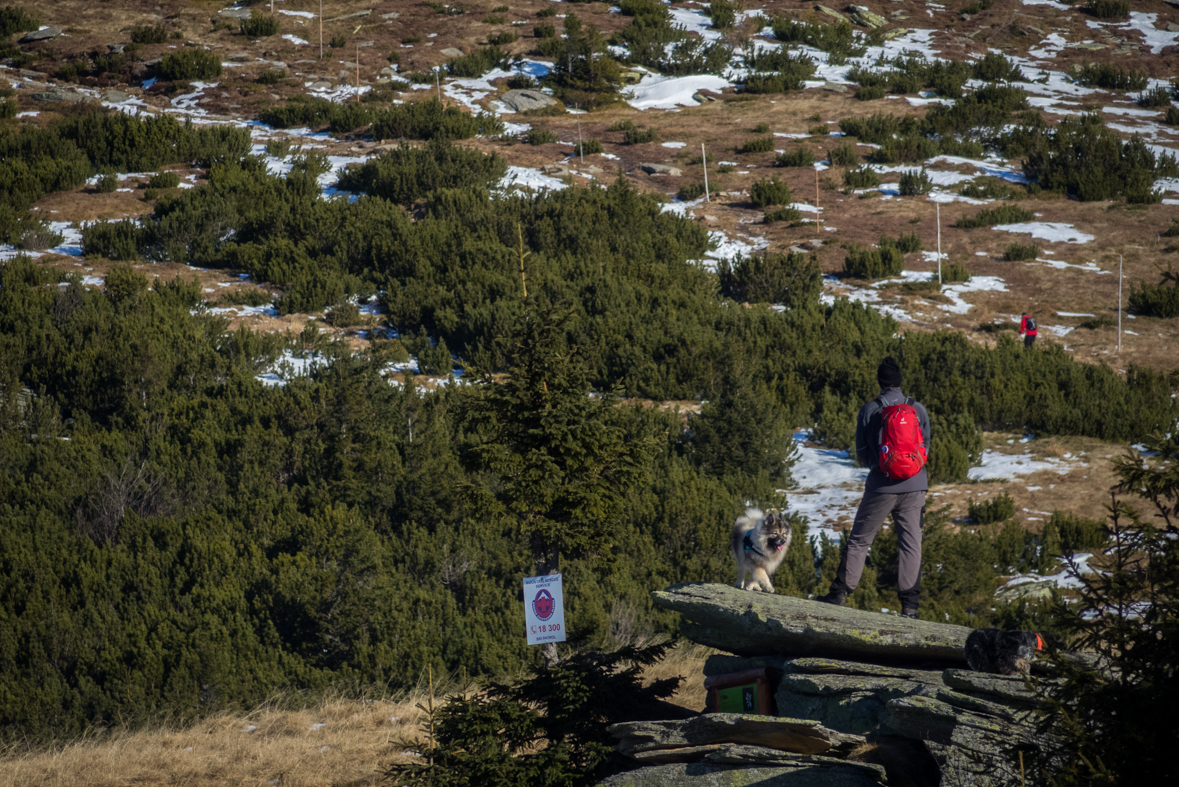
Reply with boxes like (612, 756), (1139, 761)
(0, 642), (714, 787)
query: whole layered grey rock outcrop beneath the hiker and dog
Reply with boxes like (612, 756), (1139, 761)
(601, 584), (1061, 787)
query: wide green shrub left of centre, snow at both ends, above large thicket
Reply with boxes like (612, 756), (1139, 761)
(340, 138), (507, 205)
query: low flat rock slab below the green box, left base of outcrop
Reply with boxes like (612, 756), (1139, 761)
(606, 713), (864, 756)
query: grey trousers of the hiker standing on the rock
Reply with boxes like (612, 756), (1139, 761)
(834, 490), (926, 607)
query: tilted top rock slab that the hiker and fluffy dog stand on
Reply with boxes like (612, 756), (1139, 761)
(651, 582), (970, 668)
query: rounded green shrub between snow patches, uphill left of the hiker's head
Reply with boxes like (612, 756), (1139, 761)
(717, 252), (823, 309)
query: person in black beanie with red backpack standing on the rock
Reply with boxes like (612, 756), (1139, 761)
(818, 357), (929, 617)
